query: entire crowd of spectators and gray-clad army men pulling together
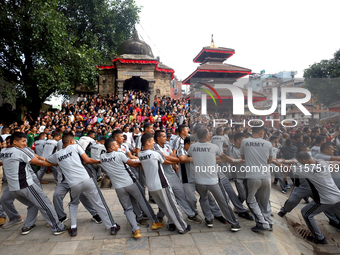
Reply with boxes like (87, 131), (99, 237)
(0, 91), (340, 244)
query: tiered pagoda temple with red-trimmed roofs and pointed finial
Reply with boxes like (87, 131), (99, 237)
(183, 35), (266, 115)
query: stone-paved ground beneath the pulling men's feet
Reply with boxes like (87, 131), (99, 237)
(0, 175), (340, 255)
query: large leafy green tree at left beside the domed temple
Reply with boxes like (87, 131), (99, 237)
(0, 0), (139, 115)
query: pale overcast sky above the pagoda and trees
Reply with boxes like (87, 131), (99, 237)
(135, 0), (340, 79)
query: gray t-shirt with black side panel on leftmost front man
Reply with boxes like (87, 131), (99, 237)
(0, 147), (34, 191)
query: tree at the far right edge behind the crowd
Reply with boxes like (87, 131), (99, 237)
(303, 50), (340, 106)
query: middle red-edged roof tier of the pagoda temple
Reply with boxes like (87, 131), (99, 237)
(183, 62), (251, 85)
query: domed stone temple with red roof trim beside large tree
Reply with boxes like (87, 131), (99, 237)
(77, 30), (175, 105)
